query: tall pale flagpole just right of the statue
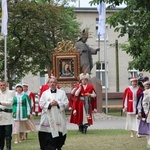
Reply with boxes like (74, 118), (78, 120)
(104, 4), (108, 114)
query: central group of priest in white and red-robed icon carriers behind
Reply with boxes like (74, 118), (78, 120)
(38, 73), (97, 150)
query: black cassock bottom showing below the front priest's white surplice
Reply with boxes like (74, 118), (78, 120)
(38, 131), (66, 150)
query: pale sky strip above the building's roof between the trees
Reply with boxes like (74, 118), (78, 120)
(70, 0), (125, 7)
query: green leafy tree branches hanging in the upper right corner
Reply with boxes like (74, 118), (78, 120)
(90, 0), (150, 71)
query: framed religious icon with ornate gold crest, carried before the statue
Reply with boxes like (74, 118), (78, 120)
(52, 41), (80, 84)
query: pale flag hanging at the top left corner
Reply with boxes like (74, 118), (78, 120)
(1, 0), (8, 36)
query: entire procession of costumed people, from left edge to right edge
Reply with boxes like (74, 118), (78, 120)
(0, 73), (150, 150)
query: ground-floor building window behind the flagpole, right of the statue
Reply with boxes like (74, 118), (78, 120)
(96, 62), (108, 88)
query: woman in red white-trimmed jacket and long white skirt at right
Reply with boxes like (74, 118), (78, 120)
(123, 78), (143, 137)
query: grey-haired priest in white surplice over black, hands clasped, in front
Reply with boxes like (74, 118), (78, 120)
(39, 77), (68, 150)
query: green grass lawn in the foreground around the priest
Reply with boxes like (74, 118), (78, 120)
(12, 130), (147, 150)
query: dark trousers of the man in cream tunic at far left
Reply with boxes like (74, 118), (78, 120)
(0, 125), (12, 150)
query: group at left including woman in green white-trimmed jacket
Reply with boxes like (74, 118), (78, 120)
(0, 80), (36, 150)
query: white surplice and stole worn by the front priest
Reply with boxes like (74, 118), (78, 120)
(39, 89), (68, 138)
